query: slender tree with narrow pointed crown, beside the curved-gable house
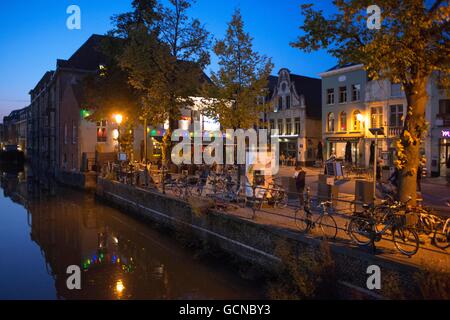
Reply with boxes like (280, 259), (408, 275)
(205, 10), (273, 185)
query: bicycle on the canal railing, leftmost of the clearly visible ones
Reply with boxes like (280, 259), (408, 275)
(294, 188), (338, 240)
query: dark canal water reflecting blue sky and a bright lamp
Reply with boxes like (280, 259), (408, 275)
(0, 170), (263, 299)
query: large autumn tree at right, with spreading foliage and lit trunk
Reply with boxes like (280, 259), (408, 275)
(292, 0), (450, 203)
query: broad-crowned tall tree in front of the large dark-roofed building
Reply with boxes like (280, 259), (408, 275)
(111, 0), (210, 163)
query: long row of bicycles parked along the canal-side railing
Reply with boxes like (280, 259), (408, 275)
(100, 160), (450, 256)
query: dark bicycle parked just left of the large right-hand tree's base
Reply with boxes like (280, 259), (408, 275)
(347, 203), (419, 257)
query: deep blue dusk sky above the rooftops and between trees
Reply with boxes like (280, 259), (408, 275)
(0, 0), (335, 119)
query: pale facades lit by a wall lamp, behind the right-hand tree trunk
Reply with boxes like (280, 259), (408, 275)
(321, 65), (450, 176)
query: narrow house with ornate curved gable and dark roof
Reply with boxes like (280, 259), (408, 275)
(262, 68), (322, 165)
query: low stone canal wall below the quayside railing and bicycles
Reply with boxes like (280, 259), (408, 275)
(96, 178), (428, 298)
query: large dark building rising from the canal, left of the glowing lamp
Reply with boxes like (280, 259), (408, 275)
(28, 35), (108, 180)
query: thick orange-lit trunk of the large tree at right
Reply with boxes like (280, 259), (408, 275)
(397, 78), (428, 205)
